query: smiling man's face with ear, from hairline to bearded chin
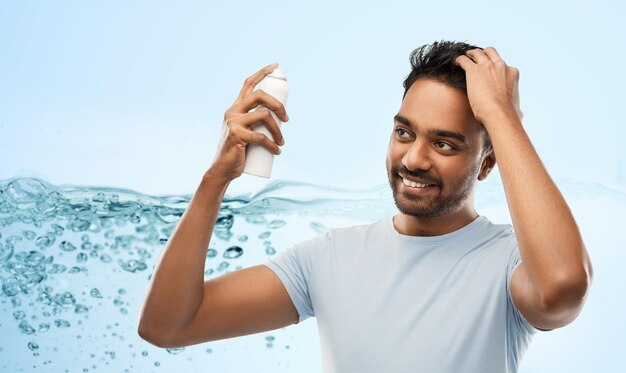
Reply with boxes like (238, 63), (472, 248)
(386, 79), (495, 217)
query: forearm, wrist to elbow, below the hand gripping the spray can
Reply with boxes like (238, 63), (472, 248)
(139, 169), (230, 338)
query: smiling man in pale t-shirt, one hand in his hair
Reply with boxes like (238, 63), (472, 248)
(139, 41), (592, 372)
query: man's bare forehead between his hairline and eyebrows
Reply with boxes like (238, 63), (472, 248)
(398, 79), (480, 138)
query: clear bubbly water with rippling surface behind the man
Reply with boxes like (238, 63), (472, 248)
(0, 178), (626, 372)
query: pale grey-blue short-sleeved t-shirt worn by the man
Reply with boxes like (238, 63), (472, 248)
(264, 216), (538, 373)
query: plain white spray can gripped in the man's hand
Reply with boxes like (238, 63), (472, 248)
(243, 68), (289, 178)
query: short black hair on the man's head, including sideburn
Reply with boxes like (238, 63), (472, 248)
(402, 40), (492, 152)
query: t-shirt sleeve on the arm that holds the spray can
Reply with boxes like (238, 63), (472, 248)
(263, 233), (330, 323)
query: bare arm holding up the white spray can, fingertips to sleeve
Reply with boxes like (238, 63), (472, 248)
(138, 65), (298, 347)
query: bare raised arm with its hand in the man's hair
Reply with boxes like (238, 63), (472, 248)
(457, 47), (593, 329)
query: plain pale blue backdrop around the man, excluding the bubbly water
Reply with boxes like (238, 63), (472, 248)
(0, 0), (626, 372)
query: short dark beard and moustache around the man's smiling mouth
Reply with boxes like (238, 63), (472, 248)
(387, 163), (480, 218)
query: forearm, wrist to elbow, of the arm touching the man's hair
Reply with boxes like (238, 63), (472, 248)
(485, 114), (591, 302)
